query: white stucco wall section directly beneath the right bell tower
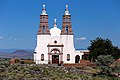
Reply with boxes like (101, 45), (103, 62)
(61, 35), (75, 63)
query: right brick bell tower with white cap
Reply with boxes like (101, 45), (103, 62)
(61, 5), (73, 35)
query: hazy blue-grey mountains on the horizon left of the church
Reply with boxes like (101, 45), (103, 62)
(0, 50), (33, 59)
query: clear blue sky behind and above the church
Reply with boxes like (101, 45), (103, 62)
(0, 0), (120, 49)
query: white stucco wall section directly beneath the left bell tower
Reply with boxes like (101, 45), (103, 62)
(35, 35), (50, 64)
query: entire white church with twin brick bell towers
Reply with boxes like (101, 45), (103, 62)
(34, 5), (89, 64)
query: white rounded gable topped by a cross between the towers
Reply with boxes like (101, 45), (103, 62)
(50, 19), (61, 37)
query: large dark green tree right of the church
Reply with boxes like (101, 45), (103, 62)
(88, 37), (120, 61)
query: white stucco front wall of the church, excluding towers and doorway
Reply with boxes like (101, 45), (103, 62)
(34, 35), (83, 64)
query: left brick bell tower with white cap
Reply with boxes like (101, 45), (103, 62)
(37, 5), (50, 35)
